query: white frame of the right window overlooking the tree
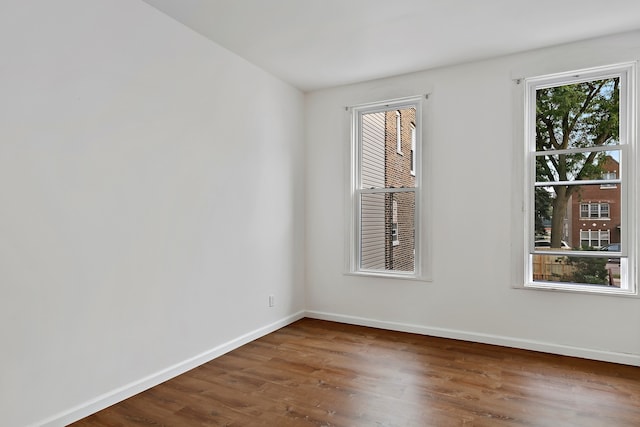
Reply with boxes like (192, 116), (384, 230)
(516, 62), (640, 296)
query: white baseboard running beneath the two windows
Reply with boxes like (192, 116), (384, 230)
(305, 310), (640, 366)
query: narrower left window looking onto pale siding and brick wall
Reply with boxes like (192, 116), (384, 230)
(350, 98), (422, 278)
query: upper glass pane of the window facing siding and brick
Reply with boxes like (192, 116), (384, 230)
(360, 107), (416, 189)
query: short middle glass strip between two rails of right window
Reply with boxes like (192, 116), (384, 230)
(536, 150), (621, 185)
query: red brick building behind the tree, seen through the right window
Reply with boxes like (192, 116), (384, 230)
(568, 156), (620, 248)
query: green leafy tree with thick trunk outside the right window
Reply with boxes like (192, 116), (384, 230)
(536, 78), (620, 248)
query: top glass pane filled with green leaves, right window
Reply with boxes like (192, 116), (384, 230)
(536, 77), (620, 151)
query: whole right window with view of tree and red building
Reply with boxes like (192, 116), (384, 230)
(524, 64), (637, 295)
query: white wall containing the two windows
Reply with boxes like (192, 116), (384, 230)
(306, 32), (640, 364)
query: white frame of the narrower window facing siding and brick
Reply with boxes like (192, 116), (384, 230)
(346, 96), (431, 281)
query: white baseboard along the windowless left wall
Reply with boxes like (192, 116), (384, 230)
(32, 311), (305, 427)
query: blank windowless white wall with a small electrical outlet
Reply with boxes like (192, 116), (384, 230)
(0, 0), (304, 426)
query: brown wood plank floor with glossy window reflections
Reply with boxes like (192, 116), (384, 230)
(73, 319), (640, 427)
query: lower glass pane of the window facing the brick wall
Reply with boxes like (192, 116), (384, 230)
(360, 191), (415, 272)
